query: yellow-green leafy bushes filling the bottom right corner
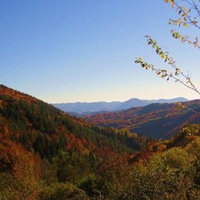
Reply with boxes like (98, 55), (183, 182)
(109, 147), (200, 200)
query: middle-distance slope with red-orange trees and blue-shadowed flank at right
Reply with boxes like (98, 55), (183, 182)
(84, 100), (200, 139)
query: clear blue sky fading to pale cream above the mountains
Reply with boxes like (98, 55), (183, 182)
(0, 0), (200, 103)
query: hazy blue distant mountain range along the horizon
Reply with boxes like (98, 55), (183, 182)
(53, 97), (188, 115)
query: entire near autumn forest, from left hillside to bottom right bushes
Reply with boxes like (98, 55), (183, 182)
(0, 85), (200, 200)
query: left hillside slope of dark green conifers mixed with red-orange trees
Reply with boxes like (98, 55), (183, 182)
(0, 85), (145, 159)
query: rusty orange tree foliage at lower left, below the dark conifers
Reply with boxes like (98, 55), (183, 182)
(0, 135), (41, 200)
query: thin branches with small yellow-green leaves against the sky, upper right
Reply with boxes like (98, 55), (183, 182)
(135, 0), (200, 94)
